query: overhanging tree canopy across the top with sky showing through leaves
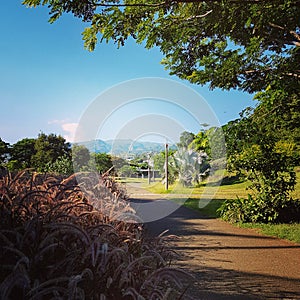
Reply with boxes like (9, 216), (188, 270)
(23, 0), (300, 92)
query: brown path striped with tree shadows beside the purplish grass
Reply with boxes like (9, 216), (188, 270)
(129, 186), (300, 299)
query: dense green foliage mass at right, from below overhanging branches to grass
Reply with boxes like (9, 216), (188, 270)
(220, 89), (300, 223)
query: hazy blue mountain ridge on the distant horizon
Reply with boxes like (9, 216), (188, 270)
(78, 140), (176, 155)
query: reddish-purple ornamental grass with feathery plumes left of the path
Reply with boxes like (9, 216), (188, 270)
(0, 172), (192, 299)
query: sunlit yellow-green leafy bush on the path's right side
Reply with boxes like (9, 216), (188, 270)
(223, 134), (300, 223)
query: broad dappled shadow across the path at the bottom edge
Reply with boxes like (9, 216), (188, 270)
(185, 266), (300, 300)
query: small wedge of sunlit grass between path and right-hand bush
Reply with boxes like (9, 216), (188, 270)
(239, 223), (300, 244)
